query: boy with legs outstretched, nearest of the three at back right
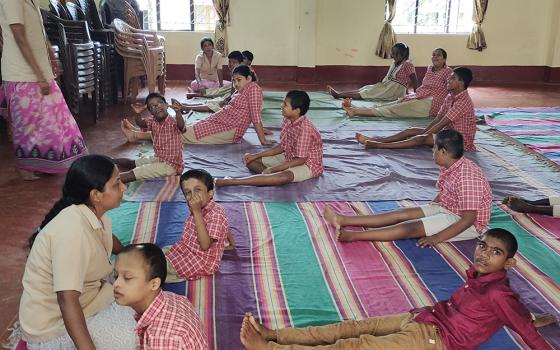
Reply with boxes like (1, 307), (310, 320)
(356, 67), (476, 151)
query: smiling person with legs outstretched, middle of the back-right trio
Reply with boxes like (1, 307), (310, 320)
(342, 48), (453, 118)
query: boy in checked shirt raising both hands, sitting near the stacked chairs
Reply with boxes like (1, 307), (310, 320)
(114, 92), (185, 183)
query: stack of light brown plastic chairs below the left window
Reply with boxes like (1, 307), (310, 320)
(113, 18), (166, 102)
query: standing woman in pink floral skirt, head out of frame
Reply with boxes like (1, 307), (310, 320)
(0, 0), (87, 180)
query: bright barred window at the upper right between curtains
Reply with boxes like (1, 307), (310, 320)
(392, 0), (473, 34)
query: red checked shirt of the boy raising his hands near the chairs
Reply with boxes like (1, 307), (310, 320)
(144, 116), (185, 175)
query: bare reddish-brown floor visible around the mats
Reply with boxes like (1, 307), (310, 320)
(0, 82), (560, 344)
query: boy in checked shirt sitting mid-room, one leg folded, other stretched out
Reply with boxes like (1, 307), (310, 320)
(216, 90), (323, 187)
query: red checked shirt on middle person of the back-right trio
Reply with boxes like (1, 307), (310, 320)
(402, 66), (453, 116)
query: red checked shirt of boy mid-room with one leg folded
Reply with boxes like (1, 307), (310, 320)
(280, 115), (323, 176)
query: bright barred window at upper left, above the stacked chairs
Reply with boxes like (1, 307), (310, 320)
(137, 0), (218, 31)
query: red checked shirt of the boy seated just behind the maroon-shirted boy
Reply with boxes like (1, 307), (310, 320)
(436, 157), (492, 234)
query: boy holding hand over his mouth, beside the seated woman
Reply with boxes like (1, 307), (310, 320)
(164, 169), (235, 282)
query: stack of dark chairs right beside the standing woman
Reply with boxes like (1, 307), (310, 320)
(41, 10), (102, 121)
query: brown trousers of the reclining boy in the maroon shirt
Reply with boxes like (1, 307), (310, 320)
(268, 313), (445, 350)
